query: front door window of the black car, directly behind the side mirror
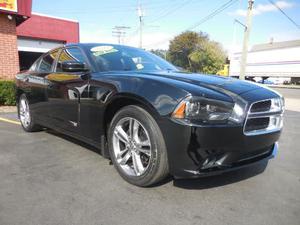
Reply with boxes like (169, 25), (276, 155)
(56, 48), (87, 72)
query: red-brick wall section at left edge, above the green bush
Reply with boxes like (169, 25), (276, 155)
(0, 14), (19, 79)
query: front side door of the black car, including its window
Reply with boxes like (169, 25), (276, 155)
(46, 47), (89, 133)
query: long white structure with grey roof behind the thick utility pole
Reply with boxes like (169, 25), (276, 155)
(229, 40), (300, 82)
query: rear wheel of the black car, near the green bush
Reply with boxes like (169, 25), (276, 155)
(18, 94), (42, 132)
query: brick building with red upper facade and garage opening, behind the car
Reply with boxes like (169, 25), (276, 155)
(0, 0), (79, 79)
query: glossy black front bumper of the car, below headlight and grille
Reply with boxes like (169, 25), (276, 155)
(161, 119), (281, 178)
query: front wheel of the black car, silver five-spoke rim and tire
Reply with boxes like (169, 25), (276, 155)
(108, 105), (169, 187)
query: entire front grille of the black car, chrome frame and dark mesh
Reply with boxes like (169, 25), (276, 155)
(244, 99), (283, 135)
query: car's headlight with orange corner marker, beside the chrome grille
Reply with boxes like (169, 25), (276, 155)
(172, 97), (245, 124)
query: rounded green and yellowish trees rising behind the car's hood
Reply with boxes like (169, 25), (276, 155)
(168, 31), (226, 74)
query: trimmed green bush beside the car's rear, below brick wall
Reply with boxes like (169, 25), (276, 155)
(0, 80), (16, 105)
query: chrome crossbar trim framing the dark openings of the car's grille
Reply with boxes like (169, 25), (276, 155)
(243, 98), (284, 136)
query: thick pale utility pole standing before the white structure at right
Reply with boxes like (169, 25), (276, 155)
(240, 0), (254, 80)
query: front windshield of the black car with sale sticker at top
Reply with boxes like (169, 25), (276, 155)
(89, 45), (177, 71)
